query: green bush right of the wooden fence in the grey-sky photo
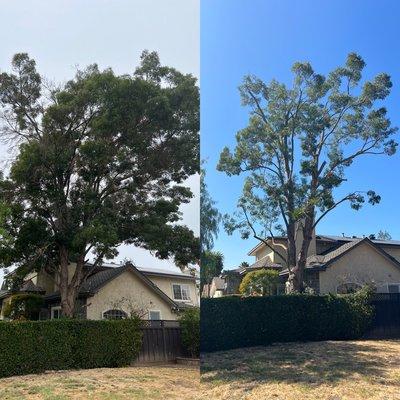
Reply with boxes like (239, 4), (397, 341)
(180, 308), (200, 357)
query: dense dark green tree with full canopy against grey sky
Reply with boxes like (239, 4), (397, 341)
(0, 52), (200, 316)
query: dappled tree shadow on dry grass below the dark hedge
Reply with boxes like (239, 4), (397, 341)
(201, 341), (400, 386)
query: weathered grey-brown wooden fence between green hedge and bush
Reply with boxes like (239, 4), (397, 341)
(135, 320), (184, 363)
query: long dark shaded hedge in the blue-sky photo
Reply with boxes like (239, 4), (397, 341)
(200, 291), (373, 352)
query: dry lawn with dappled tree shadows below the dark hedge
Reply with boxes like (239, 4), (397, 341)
(201, 341), (400, 400)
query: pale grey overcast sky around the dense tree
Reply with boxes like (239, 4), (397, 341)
(0, 0), (200, 281)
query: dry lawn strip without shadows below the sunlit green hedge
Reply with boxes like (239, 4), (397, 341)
(0, 365), (199, 400)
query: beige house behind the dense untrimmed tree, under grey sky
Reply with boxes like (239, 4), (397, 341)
(0, 263), (199, 320)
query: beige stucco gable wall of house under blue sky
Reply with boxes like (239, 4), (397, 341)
(319, 243), (400, 294)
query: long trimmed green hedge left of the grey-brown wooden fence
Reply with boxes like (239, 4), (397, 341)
(0, 319), (142, 377)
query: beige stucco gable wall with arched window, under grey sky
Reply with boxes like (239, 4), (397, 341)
(87, 271), (177, 320)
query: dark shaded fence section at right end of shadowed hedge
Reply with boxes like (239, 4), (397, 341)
(366, 293), (400, 339)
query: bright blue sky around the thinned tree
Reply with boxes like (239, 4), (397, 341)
(200, 0), (400, 268)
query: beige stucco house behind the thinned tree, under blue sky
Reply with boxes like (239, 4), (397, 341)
(212, 234), (400, 295)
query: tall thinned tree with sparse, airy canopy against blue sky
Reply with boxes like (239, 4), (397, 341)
(218, 53), (397, 291)
